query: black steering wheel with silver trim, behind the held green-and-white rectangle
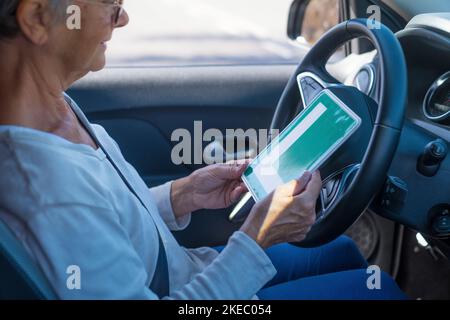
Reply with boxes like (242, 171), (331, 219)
(271, 19), (407, 247)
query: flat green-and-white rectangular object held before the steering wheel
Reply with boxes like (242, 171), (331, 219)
(242, 90), (361, 201)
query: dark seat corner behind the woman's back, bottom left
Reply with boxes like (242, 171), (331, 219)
(0, 220), (57, 300)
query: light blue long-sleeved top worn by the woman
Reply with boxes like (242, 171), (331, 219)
(0, 97), (276, 299)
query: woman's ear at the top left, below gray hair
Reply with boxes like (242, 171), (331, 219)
(16, 0), (54, 45)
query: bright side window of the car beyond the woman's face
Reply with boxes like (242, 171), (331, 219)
(108, 0), (337, 66)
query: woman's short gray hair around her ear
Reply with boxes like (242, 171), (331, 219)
(0, 0), (70, 39)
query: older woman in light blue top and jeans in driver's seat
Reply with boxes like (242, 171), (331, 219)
(0, 0), (402, 299)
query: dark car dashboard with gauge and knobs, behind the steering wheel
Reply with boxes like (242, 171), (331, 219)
(362, 13), (450, 257)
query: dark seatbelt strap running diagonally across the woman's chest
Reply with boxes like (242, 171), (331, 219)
(66, 95), (169, 298)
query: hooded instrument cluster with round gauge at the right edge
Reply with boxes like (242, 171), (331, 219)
(398, 13), (450, 142)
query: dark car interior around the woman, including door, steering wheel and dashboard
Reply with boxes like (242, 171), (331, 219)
(0, 0), (450, 300)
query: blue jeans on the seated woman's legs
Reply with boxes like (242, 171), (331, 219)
(216, 236), (406, 300)
